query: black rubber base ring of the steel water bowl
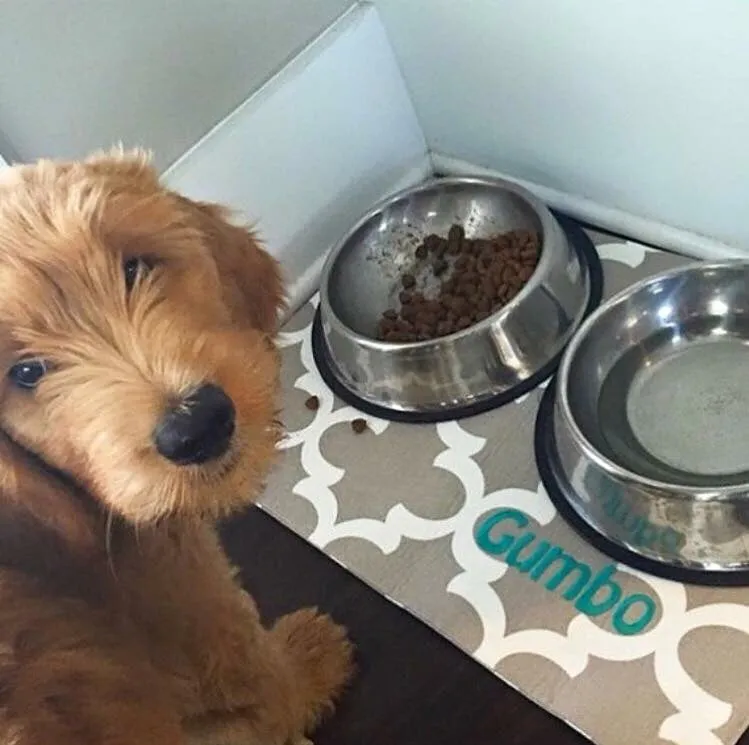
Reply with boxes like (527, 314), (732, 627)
(533, 378), (749, 587)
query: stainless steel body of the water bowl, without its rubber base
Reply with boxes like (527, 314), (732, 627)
(553, 261), (749, 573)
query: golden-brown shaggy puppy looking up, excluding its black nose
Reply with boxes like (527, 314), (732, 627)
(0, 151), (352, 745)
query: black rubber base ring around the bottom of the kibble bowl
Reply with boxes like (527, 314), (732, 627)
(312, 210), (603, 424)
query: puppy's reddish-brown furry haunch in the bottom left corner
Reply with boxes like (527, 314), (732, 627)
(0, 573), (185, 745)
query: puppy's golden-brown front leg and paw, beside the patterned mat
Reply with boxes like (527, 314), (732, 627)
(118, 524), (352, 745)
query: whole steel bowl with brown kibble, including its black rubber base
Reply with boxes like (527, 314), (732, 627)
(313, 173), (601, 422)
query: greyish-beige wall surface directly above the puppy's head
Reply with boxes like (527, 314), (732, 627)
(0, 0), (351, 167)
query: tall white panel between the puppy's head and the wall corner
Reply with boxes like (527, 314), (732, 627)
(164, 3), (430, 312)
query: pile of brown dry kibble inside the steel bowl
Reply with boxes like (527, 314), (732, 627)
(376, 225), (541, 342)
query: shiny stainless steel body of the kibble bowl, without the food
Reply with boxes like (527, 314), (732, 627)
(312, 178), (597, 417)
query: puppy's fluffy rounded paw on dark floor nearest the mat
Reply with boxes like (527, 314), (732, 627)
(273, 608), (354, 727)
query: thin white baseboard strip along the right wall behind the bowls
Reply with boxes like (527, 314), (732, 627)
(431, 153), (747, 260)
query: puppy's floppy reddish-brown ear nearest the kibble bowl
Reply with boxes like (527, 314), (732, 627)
(175, 195), (286, 335)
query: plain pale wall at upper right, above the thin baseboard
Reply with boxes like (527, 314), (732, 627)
(377, 0), (749, 250)
